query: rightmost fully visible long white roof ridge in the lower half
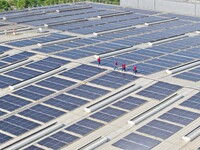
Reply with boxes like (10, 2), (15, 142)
(128, 94), (184, 125)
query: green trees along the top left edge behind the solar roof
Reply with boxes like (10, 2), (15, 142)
(0, 0), (119, 11)
